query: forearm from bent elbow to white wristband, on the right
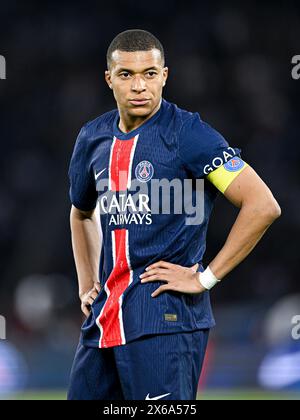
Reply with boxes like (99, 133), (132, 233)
(209, 202), (280, 280)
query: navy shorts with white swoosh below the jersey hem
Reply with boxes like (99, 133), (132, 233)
(68, 329), (209, 400)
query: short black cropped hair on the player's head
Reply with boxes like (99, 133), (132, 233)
(106, 29), (165, 69)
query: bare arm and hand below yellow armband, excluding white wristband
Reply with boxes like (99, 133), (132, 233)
(141, 167), (281, 297)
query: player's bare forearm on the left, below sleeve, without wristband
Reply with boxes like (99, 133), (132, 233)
(70, 207), (100, 296)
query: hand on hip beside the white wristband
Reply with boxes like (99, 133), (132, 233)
(140, 261), (206, 297)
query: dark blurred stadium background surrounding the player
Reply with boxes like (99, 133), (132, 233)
(0, 0), (300, 399)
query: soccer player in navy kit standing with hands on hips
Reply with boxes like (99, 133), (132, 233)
(68, 30), (280, 400)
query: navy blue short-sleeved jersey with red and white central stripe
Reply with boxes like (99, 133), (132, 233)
(69, 99), (240, 348)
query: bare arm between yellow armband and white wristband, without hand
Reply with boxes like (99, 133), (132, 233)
(209, 167), (281, 280)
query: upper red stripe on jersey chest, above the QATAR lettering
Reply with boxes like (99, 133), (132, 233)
(110, 137), (135, 191)
